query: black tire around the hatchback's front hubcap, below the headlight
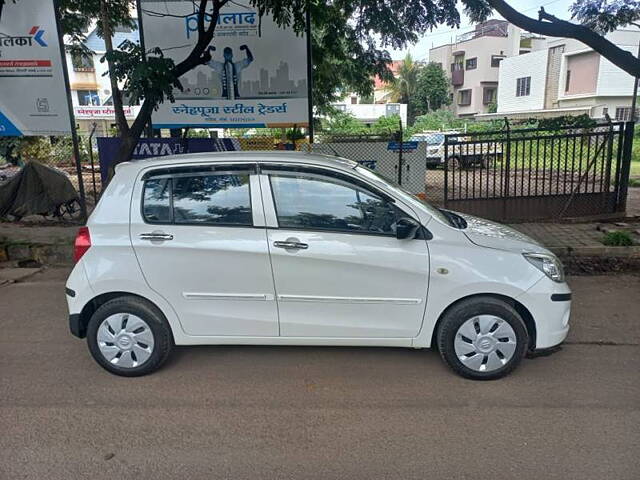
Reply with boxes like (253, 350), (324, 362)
(436, 297), (529, 380)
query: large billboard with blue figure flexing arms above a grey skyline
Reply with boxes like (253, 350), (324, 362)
(141, 0), (309, 128)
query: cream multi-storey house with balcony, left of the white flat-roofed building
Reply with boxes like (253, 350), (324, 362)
(429, 19), (544, 117)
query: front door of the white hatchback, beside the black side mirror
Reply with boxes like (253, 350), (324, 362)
(260, 166), (429, 338)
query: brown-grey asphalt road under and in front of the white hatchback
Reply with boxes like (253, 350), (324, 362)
(0, 270), (640, 480)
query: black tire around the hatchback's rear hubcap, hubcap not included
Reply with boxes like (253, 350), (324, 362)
(87, 296), (173, 377)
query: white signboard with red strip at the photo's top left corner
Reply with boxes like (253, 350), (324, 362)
(0, 0), (71, 137)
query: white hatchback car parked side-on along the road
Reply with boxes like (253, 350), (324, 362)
(66, 152), (571, 379)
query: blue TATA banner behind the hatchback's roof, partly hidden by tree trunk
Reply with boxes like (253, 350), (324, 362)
(97, 137), (240, 182)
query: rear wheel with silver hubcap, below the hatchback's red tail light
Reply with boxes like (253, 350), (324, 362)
(87, 297), (173, 377)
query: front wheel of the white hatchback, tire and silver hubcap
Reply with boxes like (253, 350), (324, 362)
(437, 297), (529, 380)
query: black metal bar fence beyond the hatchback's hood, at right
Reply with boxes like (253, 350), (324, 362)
(443, 123), (632, 221)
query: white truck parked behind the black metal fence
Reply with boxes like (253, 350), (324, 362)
(411, 130), (502, 170)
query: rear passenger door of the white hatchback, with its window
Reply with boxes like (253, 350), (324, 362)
(130, 165), (279, 337)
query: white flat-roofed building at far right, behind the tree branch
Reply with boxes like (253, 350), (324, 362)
(484, 29), (640, 121)
